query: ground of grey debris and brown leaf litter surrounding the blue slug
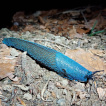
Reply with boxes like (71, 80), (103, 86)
(0, 6), (106, 106)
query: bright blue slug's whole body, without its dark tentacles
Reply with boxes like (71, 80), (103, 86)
(3, 38), (93, 82)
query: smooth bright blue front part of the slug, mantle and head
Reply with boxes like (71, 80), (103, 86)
(56, 52), (93, 82)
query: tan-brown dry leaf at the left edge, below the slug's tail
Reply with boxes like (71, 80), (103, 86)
(0, 48), (16, 79)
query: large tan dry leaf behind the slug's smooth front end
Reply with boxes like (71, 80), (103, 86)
(65, 48), (106, 73)
